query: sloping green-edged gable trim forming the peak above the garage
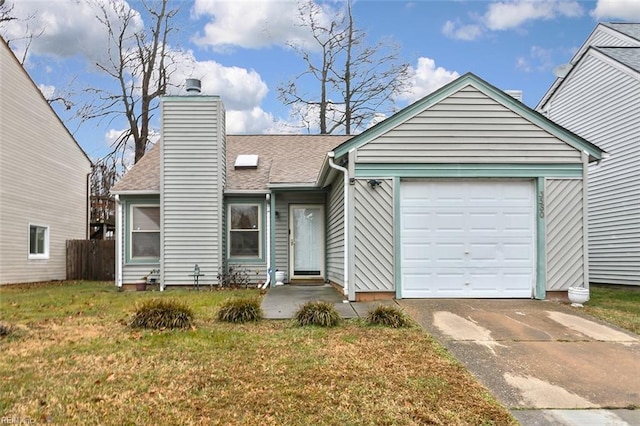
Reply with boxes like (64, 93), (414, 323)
(334, 73), (602, 161)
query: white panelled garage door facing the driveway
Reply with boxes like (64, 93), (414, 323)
(400, 180), (535, 298)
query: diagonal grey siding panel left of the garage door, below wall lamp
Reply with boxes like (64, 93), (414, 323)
(353, 179), (395, 292)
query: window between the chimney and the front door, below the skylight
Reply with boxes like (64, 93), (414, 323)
(227, 204), (262, 258)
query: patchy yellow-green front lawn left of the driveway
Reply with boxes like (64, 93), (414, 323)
(0, 282), (516, 425)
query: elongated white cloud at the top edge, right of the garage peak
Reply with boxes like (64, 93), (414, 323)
(442, 0), (584, 41)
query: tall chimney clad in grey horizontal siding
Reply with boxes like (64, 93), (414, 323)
(160, 96), (226, 286)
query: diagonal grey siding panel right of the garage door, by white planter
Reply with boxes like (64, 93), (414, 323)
(545, 179), (585, 291)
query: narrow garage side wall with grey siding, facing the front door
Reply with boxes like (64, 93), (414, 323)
(327, 175), (344, 285)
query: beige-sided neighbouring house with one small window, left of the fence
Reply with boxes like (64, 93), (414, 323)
(0, 38), (91, 284)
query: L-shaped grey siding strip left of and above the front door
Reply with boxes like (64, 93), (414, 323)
(275, 192), (326, 281)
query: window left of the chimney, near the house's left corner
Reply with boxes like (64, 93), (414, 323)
(129, 205), (160, 260)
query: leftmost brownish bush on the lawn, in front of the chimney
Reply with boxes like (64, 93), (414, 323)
(131, 299), (193, 330)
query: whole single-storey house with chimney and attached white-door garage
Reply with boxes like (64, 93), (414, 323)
(113, 74), (602, 300)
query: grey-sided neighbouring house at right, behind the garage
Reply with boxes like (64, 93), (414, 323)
(536, 23), (640, 285)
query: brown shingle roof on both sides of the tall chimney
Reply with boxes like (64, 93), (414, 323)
(112, 135), (351, 194)
